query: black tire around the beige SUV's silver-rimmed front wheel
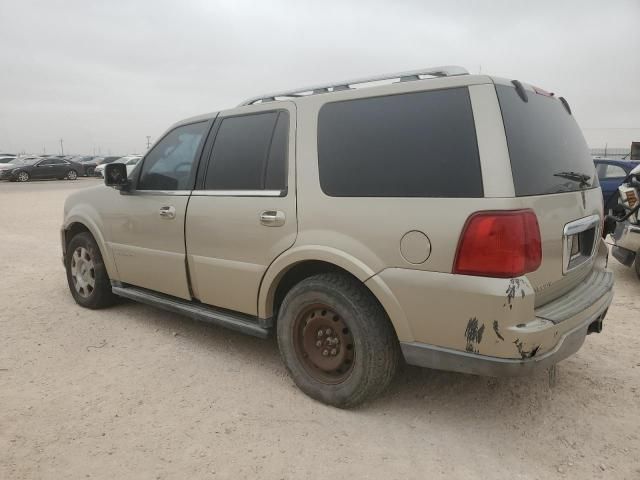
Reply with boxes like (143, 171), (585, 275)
(64, 232), (117, 309)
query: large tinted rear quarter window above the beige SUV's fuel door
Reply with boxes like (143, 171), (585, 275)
(318, 88), (483, 197)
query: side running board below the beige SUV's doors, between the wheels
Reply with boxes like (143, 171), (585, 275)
(111, 284), (271, 338)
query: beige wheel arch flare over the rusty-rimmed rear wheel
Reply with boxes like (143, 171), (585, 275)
(258, 246), (413, 341)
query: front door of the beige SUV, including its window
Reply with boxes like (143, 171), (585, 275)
(109, 121), (211, 299)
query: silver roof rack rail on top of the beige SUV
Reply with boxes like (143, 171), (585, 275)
(238, 65), (469, 107)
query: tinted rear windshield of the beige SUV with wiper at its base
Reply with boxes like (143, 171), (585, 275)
(496, 85), (599, 197)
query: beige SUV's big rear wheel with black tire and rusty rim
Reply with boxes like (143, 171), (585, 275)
(277, 273), (400, 408)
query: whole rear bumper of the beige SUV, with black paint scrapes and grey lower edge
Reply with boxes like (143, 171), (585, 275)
(369, 238), (614, 376)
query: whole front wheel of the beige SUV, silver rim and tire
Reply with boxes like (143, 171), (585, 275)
(65, 232), (117, 309)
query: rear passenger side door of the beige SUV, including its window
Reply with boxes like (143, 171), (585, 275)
(185, 102), (297, 315)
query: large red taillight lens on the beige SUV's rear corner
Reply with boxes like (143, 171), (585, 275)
(453, 210), (542, 278)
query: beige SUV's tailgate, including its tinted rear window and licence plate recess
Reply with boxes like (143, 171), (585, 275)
(496, 84), (603, 306)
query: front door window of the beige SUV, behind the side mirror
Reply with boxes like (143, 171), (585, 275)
(136, 122), (207, 190)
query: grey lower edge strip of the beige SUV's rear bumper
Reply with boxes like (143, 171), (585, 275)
(400, 291), (613, 377)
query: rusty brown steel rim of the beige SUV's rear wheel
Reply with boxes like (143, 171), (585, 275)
(293, 304), (356, 385)
